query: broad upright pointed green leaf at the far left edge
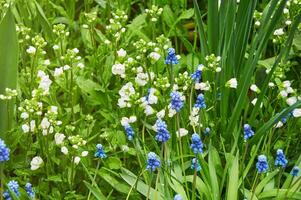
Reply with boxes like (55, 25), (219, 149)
(0, 9), (18, 135)
